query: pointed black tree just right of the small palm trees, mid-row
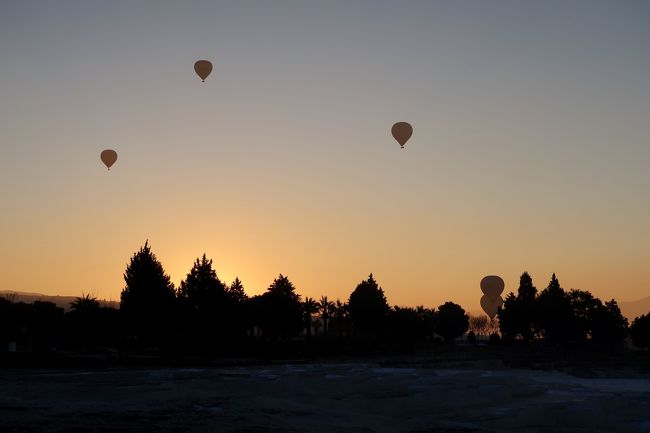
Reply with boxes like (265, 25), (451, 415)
(348, 274), (390, 335)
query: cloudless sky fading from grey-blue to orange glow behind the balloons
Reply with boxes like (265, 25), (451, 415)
(0, 0), (650, 311)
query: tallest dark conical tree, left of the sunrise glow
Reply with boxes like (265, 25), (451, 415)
(120, 241), (176, 336)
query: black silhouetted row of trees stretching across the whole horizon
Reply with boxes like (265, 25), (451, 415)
(0, 242), (650, 357)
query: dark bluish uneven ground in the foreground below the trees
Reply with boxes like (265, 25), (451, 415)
(0, 361), (650, 433)
